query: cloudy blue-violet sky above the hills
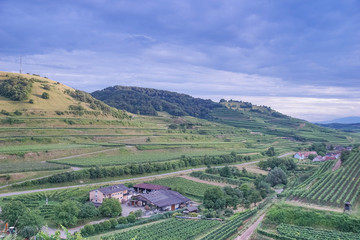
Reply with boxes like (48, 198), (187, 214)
(0, 0), (360, 121)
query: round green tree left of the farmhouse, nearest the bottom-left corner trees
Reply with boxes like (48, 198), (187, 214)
(54, 200), (80, 227)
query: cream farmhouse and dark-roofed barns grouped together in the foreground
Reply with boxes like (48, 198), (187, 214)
(89, 183), (190, 211)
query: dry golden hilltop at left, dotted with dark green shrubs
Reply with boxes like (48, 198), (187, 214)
(0, 72), (128, 118)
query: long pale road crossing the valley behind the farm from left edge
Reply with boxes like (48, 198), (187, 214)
(0, 160), (259, 198)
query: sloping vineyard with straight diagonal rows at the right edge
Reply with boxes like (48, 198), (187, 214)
(290, 150), (360, 207)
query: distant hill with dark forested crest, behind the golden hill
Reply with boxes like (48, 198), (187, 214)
(92, 86), (353, 144)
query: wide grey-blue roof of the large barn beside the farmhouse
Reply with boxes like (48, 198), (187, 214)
(140, 189), (190, 207)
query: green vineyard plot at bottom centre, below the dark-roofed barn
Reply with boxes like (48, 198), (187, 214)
(102, 219), (220, 240)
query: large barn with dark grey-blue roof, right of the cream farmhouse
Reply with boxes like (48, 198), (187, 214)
(132, 189), (190, 211)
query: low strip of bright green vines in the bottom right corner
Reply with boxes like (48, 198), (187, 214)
(277, 224), (360, 240)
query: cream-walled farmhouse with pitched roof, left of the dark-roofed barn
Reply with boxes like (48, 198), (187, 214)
(89, 184), (129, 205)
